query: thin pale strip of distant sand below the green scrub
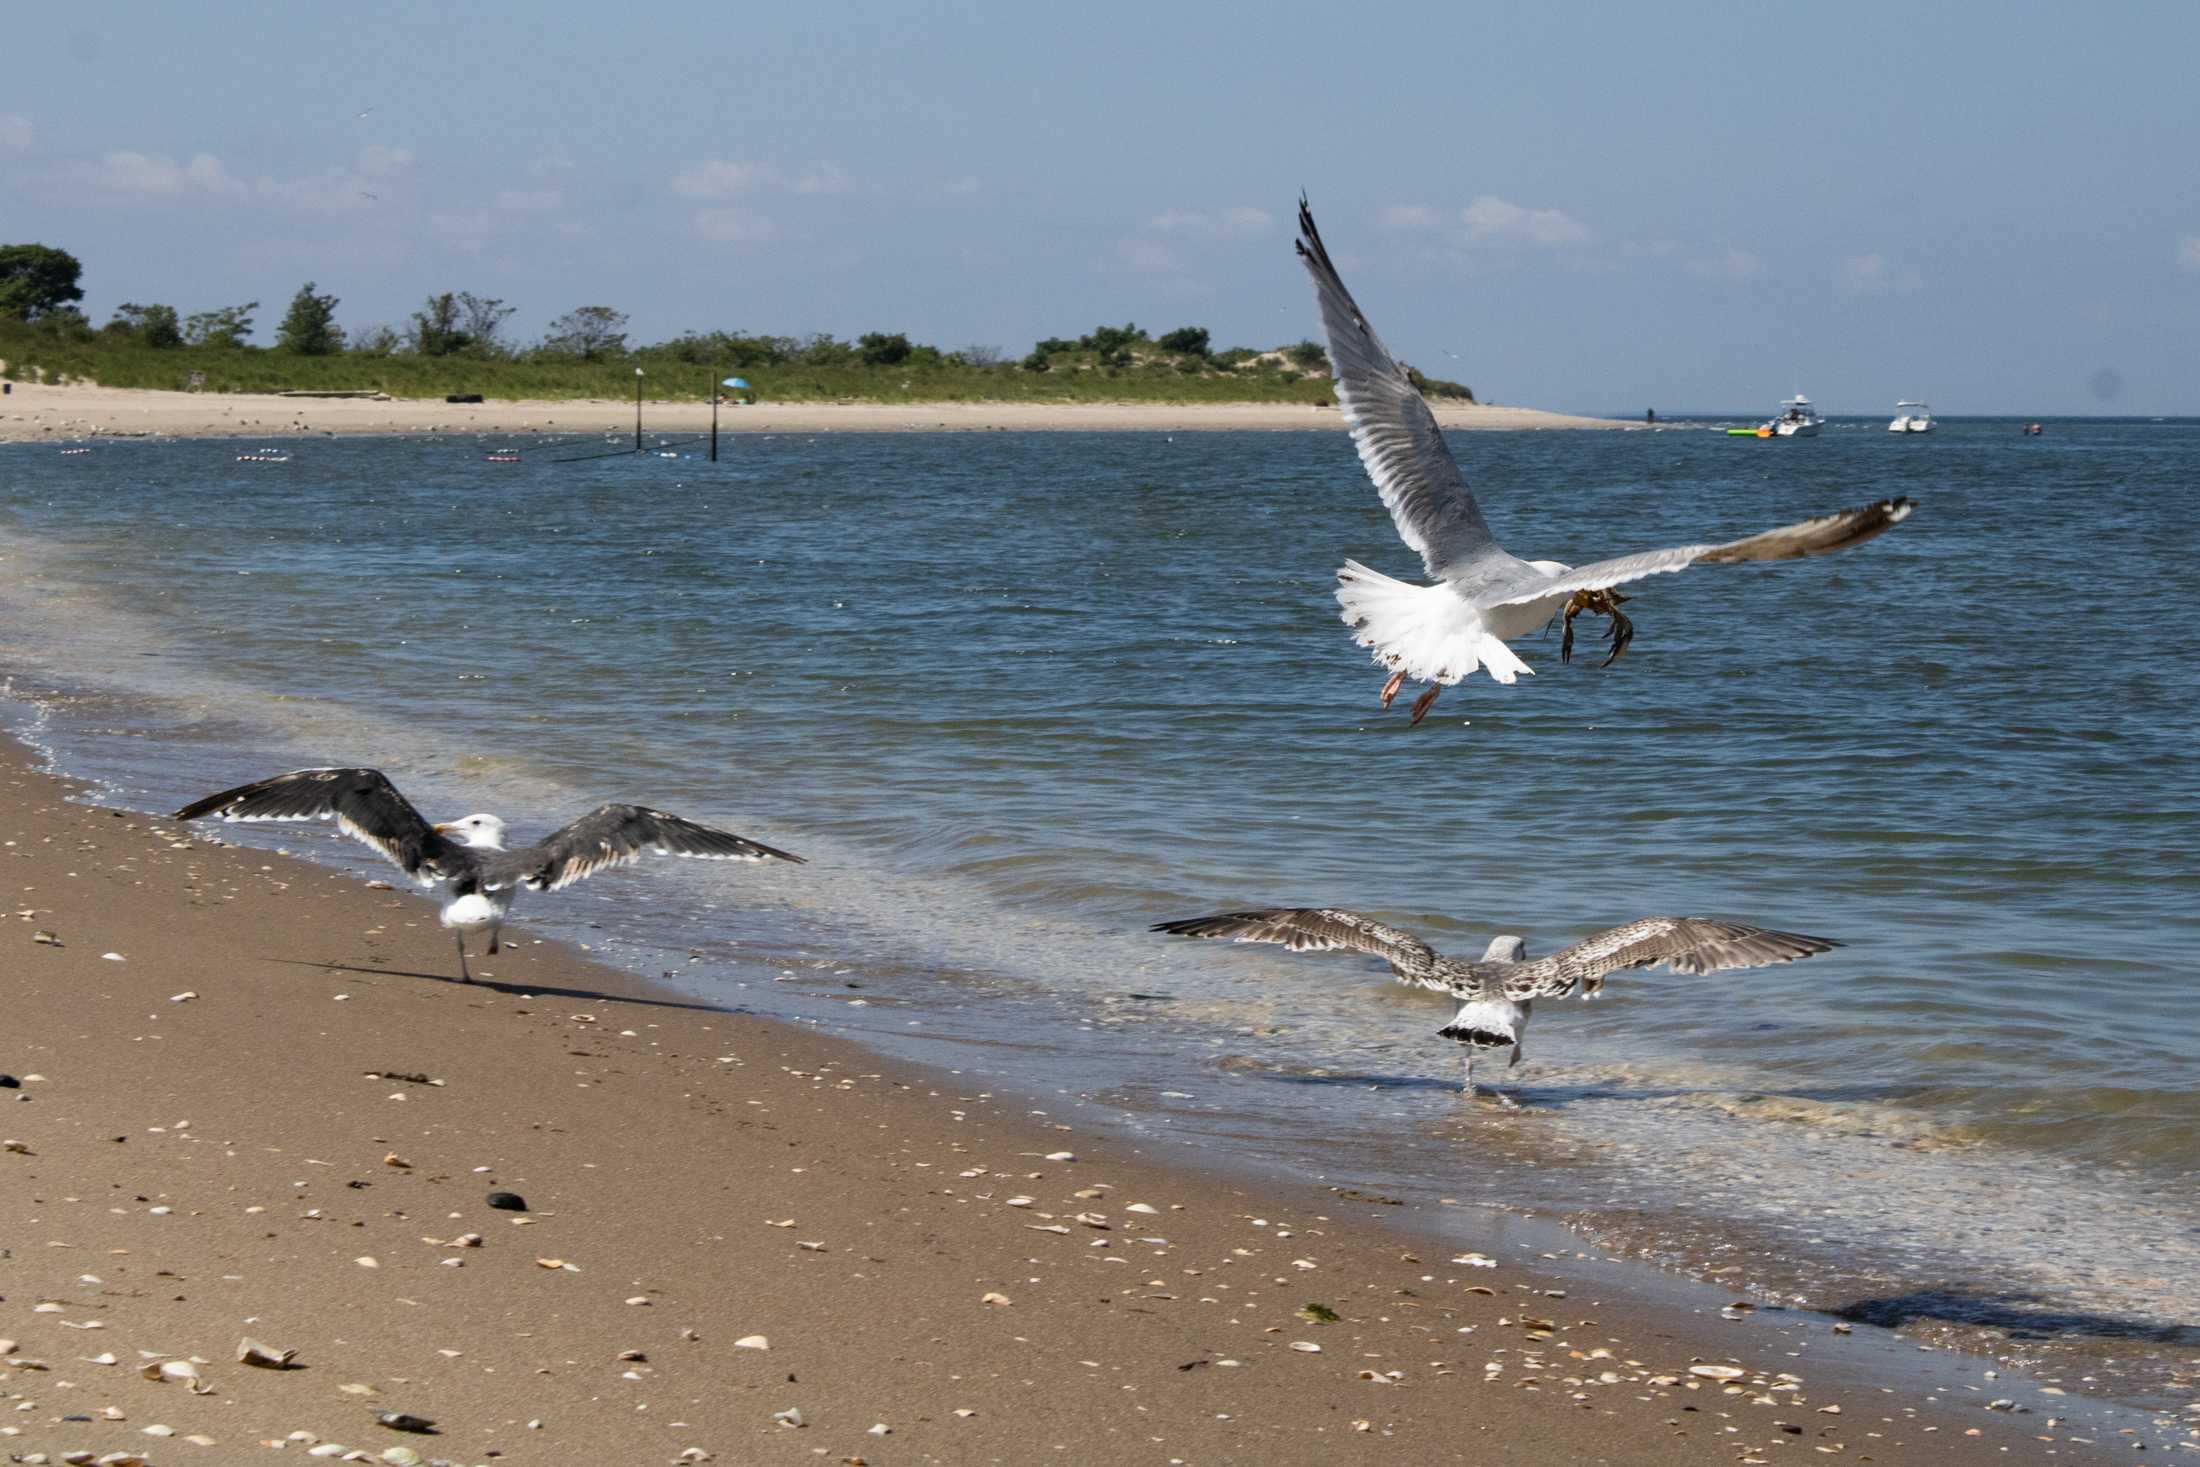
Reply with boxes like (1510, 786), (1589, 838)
(0, 383), (1632, 442)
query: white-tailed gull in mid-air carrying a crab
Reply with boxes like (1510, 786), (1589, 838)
(1298, 198), (1910, 724)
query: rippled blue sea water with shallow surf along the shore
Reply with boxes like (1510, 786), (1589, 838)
(0, 420), (2200, 1399)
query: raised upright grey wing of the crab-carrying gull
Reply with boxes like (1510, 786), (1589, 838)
(1298, 196), (1498, 576)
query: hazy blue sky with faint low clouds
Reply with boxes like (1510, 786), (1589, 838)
(0, 0), (2200, 413)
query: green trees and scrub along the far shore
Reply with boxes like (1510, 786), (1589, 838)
(0, 244), (1474, 402)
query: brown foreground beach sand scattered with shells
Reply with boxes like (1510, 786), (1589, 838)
(0, 743), (2130, 1467)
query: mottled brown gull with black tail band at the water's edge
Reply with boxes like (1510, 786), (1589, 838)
(1153, 906), (1841, 1106)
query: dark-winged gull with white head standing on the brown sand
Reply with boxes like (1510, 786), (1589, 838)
(176, 770), (803, 983)
